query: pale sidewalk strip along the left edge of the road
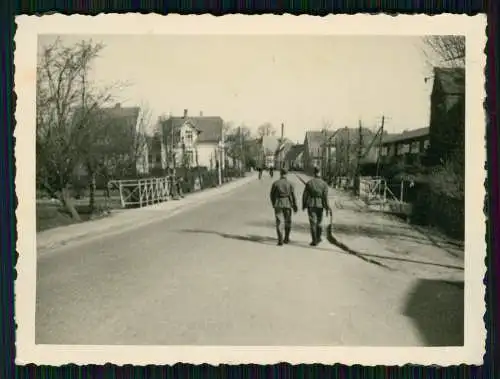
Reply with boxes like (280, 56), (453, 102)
(36, 175), (255, 252)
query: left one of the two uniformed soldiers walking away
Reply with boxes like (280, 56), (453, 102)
(271, 169), (298, 246)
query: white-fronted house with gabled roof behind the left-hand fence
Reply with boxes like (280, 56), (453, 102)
(161, 109), (225, 169)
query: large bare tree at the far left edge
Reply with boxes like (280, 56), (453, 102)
(36, 40), (118, 220)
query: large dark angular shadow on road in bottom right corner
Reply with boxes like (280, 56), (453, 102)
(403, 279), (465, 346)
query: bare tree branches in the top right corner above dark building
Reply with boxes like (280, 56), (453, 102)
(423, 35), (466, 67)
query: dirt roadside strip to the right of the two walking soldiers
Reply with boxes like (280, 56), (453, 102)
(297, 173), (464, 281)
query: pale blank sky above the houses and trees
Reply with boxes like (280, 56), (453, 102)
(39, 35), (431, 142)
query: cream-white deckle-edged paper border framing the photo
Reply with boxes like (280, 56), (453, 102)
(14, 14), (486, 366)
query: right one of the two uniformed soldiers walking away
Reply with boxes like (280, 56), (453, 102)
(302, 167), (331, 246)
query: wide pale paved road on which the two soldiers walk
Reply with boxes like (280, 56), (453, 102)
(36, 176), (463, 346)
